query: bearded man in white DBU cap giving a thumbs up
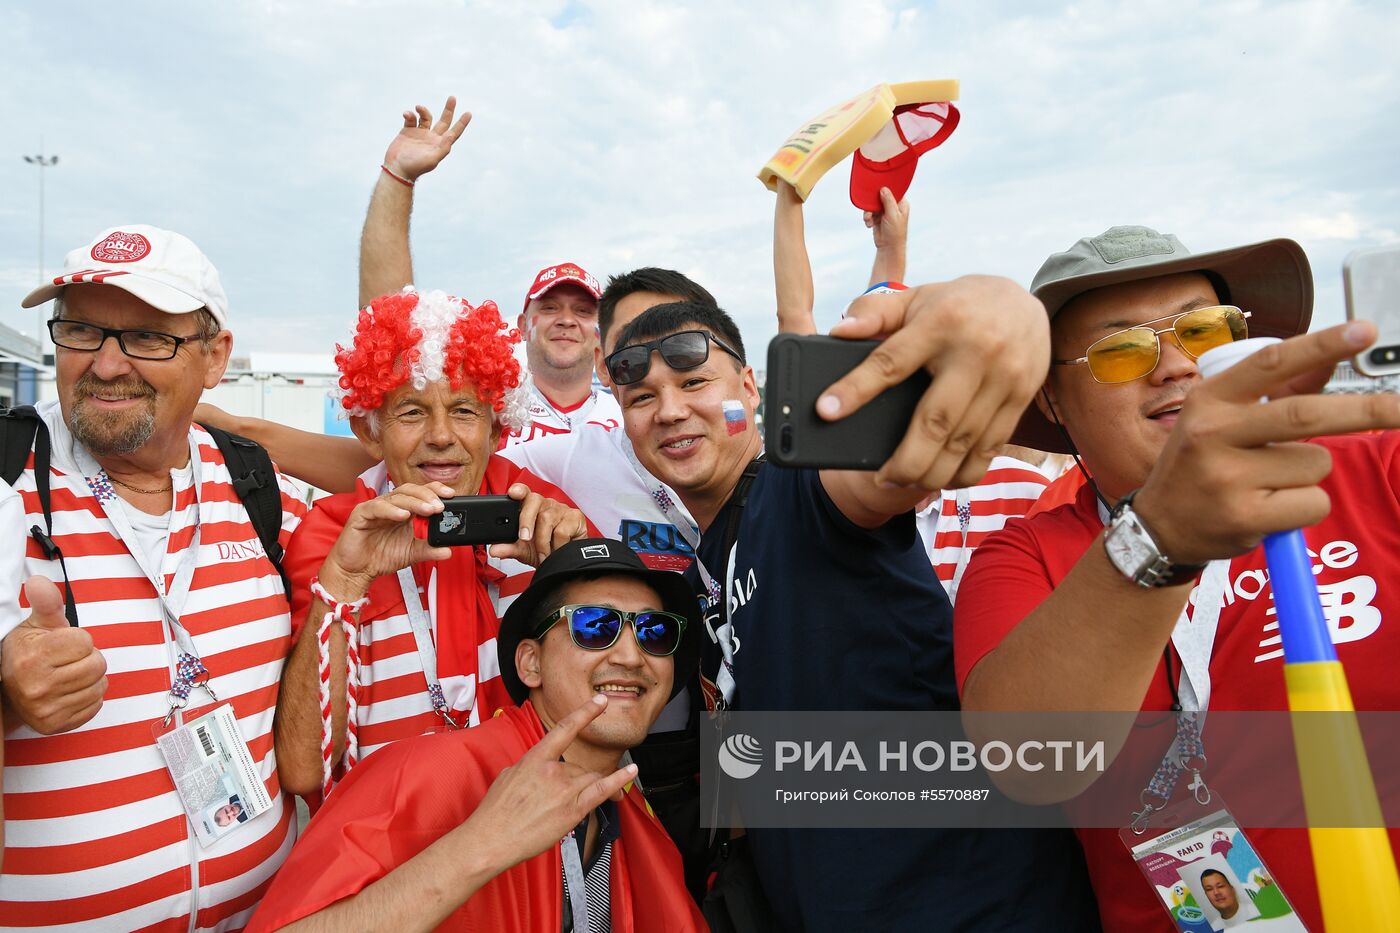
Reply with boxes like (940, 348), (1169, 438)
(0, 226), (305, 930)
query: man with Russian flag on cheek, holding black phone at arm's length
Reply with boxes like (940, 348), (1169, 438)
(606, 295), (1095, 930)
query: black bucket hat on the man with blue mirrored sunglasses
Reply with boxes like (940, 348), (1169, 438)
(496, 538), (704, 703)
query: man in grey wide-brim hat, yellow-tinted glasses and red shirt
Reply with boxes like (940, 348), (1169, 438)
(956, 227), (1400, 930)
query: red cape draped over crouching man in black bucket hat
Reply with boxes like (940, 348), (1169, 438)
(248, 703), (708, 933)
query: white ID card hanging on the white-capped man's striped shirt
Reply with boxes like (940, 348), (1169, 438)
(155, 703), (272, 848)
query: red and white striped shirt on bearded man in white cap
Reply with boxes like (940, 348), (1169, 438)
(0, 402), (305, 932)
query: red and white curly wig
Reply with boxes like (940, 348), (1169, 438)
(336, 287), (529, 430)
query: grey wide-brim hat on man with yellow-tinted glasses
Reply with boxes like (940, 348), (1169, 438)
(1011, 227), (1313, 454)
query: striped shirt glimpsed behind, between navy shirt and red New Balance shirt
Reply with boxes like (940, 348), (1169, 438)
(916, 457), (1050, 600)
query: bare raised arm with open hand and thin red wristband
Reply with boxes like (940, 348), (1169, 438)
(360, 97), (472, 308)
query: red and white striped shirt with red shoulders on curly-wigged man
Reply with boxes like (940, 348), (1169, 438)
(286, 455), (598, 766)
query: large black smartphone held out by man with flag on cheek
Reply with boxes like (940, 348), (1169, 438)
(763, 333), (932, 469)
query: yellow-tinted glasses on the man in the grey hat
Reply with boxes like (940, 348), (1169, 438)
(1054, 304), (1249, 385)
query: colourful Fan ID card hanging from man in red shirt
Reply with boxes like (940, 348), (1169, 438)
(1120, 797), (1308, 933)
